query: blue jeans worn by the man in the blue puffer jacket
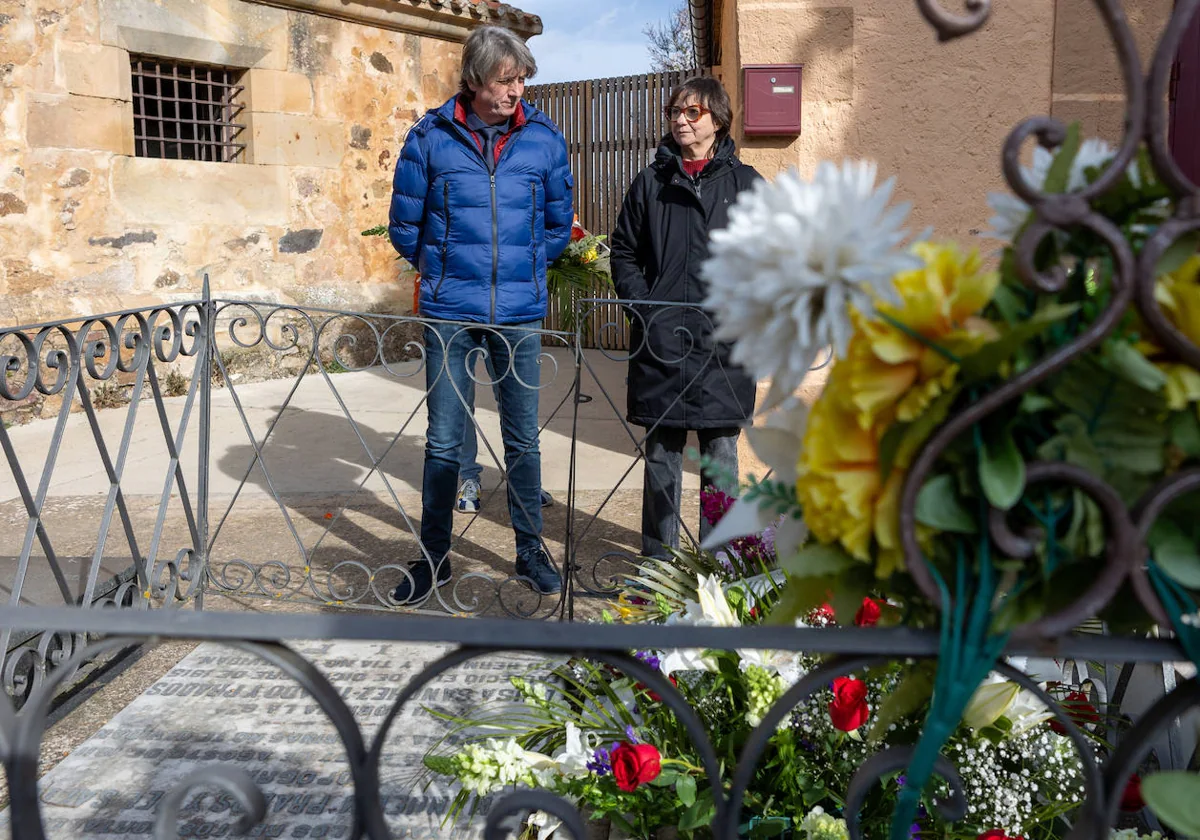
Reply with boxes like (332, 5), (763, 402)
(421, 322), (541, 563)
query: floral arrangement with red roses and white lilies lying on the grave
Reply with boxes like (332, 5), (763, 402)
(425, 488), (1111, 840)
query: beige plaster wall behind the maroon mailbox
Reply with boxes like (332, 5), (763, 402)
(726, 0), (1055, 241)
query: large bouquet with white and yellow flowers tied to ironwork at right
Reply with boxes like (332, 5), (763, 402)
(704, 125), (1200, 840)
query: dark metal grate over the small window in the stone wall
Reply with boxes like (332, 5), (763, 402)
(130, 55), (246, 163)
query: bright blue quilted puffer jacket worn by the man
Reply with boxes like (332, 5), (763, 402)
(388, 96), (575, 324)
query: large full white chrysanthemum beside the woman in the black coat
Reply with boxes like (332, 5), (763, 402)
(702, 161), (919, 410)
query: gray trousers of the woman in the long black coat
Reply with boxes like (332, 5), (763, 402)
(642, 426), (742, 559)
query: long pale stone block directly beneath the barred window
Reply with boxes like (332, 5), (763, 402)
(112, 157), (289, 227)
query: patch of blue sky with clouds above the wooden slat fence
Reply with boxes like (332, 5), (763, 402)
(508, 0), (678, 84)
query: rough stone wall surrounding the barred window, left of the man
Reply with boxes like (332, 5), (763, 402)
(0, 0), (461, 324)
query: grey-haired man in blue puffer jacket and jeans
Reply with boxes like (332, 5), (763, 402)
(388, 26), (574, 605)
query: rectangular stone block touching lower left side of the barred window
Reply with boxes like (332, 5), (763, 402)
(26, 95), (133, 155)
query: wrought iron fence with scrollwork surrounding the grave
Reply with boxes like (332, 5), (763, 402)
(0, 0), (1200, 840)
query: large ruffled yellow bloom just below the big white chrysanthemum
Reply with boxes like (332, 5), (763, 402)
(796, 244), (998, 576)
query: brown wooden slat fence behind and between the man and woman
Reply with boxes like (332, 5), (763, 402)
(524, 71), (696, 349)
